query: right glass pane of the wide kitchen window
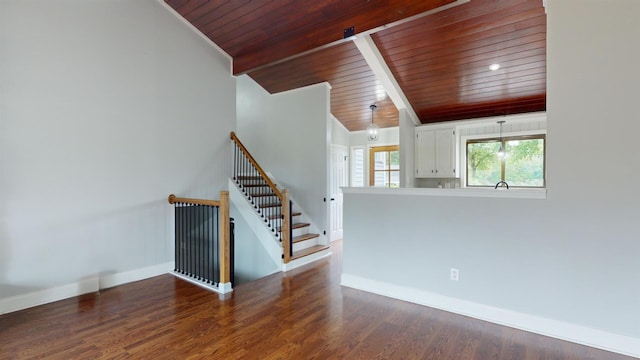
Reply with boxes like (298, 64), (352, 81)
(504, 139), (544, 186)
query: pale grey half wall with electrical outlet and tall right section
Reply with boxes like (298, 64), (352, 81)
(344, 0), (640, 356)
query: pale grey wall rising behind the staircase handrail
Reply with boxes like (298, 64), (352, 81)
(237, 75), (332, 240)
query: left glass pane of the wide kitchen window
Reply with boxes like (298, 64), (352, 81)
(467, 141), (502, 186)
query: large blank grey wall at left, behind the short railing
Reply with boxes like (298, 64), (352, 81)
(0, 0), (235, 312)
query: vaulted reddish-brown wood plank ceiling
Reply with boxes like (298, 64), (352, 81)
(165, 0), (546, 131)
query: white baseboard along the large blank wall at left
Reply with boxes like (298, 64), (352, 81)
(0, 262), (173, 314)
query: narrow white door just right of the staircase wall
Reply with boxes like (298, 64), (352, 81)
(329, 145), (349, 241)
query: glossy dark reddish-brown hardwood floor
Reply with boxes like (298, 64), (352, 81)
(0, 243), (632, 360)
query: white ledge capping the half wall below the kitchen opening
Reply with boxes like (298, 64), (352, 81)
(342, 187), (547, 199)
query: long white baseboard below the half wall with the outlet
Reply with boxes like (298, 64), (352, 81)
(341, 273), (640, 358)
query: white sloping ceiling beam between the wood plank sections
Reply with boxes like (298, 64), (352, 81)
(353, 35), (421, 125)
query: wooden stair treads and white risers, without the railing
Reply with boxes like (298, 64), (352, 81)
(234, 175), (329, 260)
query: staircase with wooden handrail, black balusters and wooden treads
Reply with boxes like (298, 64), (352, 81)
(230, 132), (331, 271)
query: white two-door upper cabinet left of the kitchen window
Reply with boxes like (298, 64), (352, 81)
(415, 128), (458, 178)
